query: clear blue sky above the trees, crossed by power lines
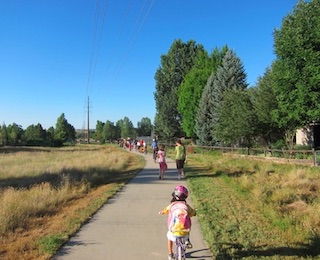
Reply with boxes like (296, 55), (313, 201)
(0, 0), (298, 129)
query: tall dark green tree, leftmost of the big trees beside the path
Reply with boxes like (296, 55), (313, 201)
(154, 40), (203, 140)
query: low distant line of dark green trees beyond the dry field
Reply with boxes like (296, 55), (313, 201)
(0, 114), (152, 146)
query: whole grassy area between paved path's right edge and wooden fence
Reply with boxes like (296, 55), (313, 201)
(186, 153), (320, 259)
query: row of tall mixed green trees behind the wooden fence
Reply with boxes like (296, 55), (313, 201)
(154, 0), (320, 147)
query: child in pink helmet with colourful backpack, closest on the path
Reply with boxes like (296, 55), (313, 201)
(159, 185), (196, 260)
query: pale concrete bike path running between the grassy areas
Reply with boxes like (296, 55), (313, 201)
(53, 150), (212, 260)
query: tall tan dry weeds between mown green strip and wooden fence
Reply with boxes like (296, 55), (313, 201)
(234, 159), (320, 237)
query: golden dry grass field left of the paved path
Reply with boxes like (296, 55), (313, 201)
(0, 145), (144, 259)
